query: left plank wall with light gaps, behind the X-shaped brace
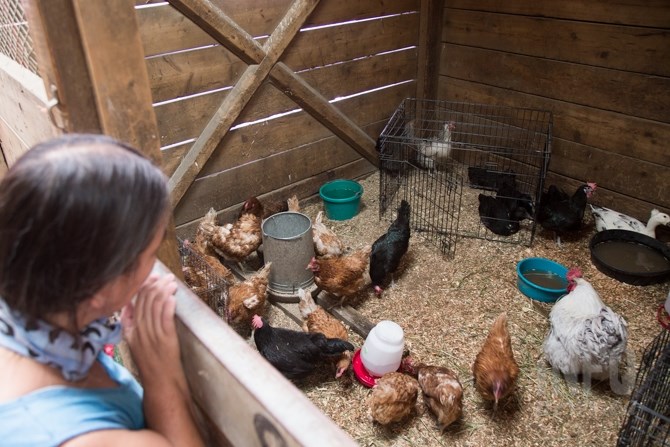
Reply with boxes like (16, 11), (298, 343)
(136, 0), (419, 235)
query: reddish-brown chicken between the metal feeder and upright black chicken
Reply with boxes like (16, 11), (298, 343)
(307, 247), (372, 305)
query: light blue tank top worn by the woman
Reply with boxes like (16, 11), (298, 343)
(0, 352), (145, 447)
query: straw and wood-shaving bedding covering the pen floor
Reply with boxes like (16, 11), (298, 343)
(260, 174), (669, 447)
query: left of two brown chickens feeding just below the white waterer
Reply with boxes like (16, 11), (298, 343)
(367, 372), (419, 425)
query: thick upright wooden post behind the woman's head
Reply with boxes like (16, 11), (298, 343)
(24, 0), (181, 278)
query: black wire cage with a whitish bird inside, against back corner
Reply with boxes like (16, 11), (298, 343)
(377, 98), (552, 256)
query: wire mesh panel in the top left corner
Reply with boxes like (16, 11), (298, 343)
(0, 0), (39, 74)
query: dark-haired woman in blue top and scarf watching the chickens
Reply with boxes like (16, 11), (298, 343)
(0, 135), (203, 447)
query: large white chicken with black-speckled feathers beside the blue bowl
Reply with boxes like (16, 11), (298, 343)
(543, 269), (628, 380)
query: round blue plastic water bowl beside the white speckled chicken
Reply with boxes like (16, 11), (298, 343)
(516, 258), (568, 303)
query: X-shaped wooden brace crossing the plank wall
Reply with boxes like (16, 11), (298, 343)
(169, 0), (379, 206)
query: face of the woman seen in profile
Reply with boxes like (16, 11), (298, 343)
(99, 223), (166, 317)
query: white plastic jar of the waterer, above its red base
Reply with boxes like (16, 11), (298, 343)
(361, 320), (405, 377)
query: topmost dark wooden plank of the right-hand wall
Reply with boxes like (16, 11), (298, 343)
(446, 0), (670, 28)
